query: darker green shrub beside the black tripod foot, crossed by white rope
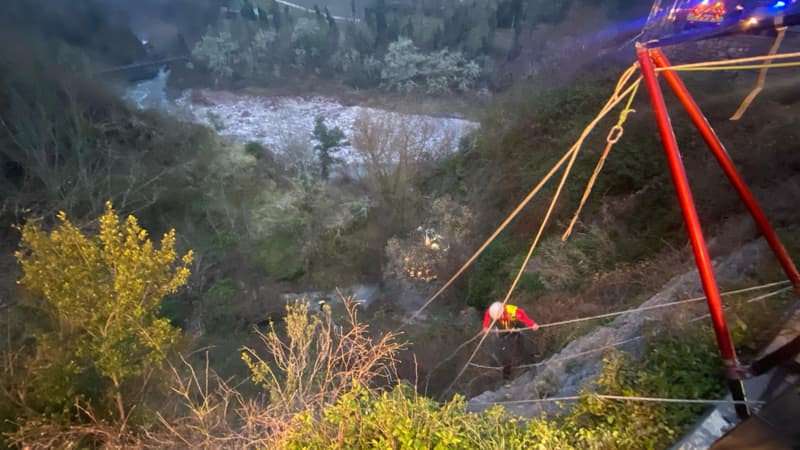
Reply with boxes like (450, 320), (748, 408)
(564, 329), (724, 449)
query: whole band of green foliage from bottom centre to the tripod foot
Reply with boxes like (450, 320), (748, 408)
(288, 326), (722, 450)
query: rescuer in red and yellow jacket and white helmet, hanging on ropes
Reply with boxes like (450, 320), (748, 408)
(483, 302), (539, 380)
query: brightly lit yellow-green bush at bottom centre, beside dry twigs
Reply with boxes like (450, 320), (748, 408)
(287, 385), (552, 450)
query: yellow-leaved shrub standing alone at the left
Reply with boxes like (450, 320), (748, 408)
(15, 202), (192, 400)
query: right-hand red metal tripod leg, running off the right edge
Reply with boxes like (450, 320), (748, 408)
(650, 48), (800, 294)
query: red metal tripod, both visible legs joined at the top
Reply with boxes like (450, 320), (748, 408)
(636, 45), (800, 418)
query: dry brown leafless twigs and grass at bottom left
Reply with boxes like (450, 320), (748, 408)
(10, 299), (402, 449)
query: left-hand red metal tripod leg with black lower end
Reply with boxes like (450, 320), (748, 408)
(636, 45), (749, 418)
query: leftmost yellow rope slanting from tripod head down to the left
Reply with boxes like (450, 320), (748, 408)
(408, 63), (641, 321)
